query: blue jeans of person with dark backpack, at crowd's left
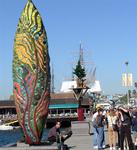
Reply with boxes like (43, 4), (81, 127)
(96, 127), (104, 150)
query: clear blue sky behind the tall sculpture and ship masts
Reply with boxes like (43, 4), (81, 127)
(0, 0), (137, 99)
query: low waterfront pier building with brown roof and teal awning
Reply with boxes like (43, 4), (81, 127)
(0, 92), (90, 123)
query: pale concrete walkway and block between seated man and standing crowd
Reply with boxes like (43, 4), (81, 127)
(65, 121), (109, 150)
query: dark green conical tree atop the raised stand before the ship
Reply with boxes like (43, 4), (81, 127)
(73, 60), (86, 80)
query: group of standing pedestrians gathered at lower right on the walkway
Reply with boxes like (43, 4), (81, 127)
(91, 106), (137, 150)
